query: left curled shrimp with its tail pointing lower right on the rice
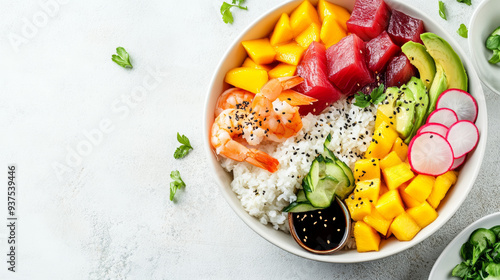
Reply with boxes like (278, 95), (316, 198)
(210, 109), (279, 173)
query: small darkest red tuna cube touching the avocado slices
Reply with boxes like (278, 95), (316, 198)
(385, 53), (417, 87)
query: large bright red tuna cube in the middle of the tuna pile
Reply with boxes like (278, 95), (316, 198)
(326, 34), (375, 94)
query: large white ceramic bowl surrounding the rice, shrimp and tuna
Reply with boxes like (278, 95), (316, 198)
(203, 0), (488, 263)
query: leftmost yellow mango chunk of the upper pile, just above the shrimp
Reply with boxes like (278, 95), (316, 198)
(224, 67), (268, 93)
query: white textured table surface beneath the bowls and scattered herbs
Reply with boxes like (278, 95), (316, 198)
(0, 0), (500, 279)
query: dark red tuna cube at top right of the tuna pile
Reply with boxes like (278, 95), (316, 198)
(387, 10), (424, 46)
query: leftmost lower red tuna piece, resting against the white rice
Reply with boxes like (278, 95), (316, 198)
(296, 42), (341, 115)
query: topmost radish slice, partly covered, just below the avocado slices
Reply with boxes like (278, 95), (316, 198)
(436, 88), (477, 122)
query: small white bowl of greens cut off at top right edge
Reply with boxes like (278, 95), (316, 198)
(468, 0), (500, 94)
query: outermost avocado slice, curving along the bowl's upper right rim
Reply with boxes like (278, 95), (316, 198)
(420, 33), (468, 91)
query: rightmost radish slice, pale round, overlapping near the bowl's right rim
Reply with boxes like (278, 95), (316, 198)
(446, 121), (479, 158)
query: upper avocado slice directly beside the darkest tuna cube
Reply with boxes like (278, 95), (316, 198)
(401, 41), (436, 90)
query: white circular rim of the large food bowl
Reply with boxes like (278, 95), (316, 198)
(202, 0), (488, 263)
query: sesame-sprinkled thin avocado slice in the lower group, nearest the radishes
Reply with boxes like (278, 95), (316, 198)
(405, 77), (429, 144)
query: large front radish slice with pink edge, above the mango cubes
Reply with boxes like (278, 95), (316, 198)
(408, 132), (453, 176)
